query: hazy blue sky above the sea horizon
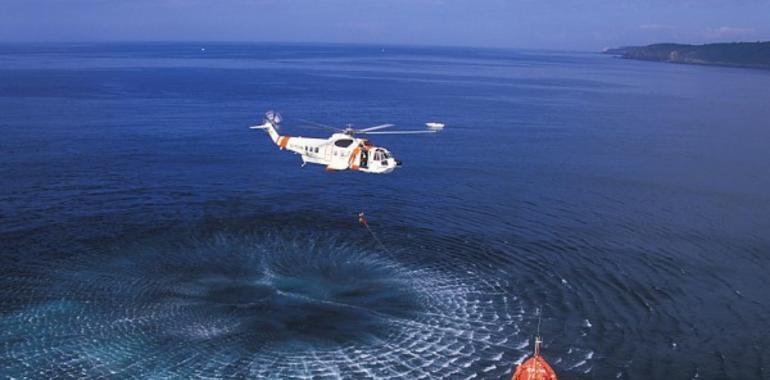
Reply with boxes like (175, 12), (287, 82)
(0, 0), (770, 51)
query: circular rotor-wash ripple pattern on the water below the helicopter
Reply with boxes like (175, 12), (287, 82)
(0, 217), (528, 378)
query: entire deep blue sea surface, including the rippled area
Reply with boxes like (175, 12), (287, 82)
(0, 44), (770, 379)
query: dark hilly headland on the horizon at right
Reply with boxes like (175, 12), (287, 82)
(603, 41), (770, 70)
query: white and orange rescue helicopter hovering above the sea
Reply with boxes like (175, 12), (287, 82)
(249, 111), (437, 174)
